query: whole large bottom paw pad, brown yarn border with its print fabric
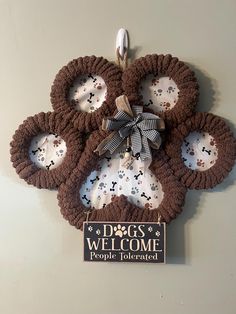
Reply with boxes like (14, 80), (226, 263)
(58, 131), (186, 228)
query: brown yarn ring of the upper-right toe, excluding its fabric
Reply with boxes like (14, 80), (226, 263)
(122, 54), (199, 127)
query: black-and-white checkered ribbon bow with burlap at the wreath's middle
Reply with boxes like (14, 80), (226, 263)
(96, 95), (165, 160)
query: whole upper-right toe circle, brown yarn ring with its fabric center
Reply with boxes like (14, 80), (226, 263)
(123, 54), (199, 127)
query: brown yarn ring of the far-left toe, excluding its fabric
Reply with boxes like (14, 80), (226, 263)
(10, 112), (85, 189)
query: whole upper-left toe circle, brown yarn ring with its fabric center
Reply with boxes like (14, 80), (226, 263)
(51, 56), (122, 132)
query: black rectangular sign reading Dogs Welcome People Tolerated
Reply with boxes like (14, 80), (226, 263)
(83, 221), (166, 263)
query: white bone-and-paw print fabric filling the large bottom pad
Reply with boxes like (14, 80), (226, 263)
(80, 150), (164, 209)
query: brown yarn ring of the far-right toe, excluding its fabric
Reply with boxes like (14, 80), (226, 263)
(165, 112), (236, 189)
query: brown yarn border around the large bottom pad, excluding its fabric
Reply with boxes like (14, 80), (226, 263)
(58, 130), (186, 229)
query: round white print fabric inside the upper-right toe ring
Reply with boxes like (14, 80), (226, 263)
(139, 74), (179, 113)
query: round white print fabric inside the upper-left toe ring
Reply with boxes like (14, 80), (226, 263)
(69, 74), (107, 112)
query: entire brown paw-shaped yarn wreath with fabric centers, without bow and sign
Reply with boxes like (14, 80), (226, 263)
(11, 54), (236, 229)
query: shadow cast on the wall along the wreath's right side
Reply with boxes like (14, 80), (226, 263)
(167, 64), (236, 264)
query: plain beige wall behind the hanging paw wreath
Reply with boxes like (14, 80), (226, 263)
(0, 0), (236, 314)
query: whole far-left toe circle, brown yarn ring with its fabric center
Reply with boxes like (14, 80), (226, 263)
(10, 112), (84, 189)
